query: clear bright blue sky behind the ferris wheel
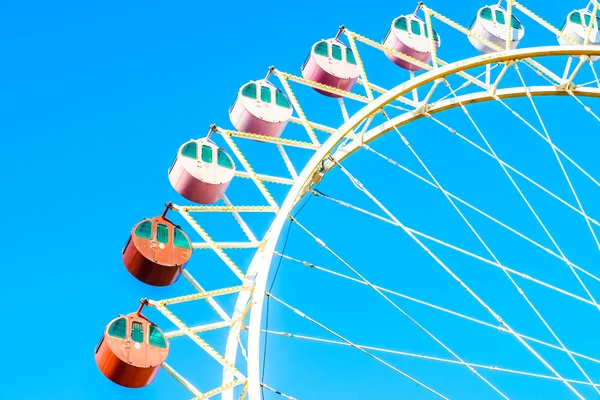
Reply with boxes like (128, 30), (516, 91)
(0, 0), (600, 400)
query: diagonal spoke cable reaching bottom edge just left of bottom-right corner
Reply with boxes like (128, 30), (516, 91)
(334, 161), (583, 399)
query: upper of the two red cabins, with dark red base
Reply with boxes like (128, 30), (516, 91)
(123, 216), (192, 286)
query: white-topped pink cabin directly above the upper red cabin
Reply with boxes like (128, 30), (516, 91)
(169, 139), (237, 204)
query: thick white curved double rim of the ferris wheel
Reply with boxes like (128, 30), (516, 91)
(222, 45), (600, 400)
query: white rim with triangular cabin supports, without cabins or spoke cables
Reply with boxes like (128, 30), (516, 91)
(115, 0), (600, 400)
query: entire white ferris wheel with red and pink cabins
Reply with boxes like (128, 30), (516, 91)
(95, 0), (600, 400)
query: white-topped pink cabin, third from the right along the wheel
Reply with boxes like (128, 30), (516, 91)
(383, 15), (441, 71)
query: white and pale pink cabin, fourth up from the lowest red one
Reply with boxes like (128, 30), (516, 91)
(229, 79), (292, 137)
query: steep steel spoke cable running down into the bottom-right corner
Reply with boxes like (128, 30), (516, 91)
(384, 104), (600, 394)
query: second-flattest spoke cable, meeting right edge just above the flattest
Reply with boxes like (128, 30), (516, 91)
(274, 253), (600, 364)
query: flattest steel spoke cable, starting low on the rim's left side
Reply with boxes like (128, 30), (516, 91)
(261, 330), (600, 387)
